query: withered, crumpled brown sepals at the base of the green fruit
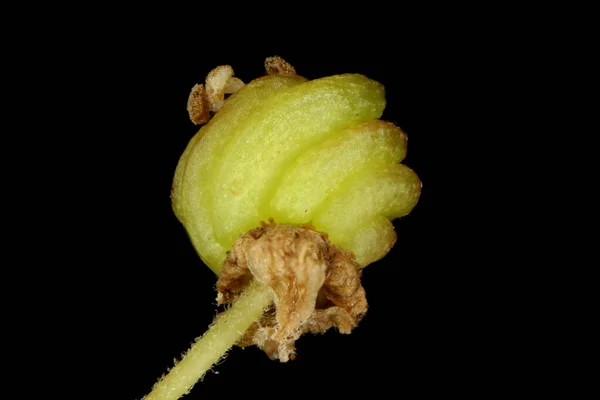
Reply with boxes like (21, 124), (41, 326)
(217, 220), (367, 362)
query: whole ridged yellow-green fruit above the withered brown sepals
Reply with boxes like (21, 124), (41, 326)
(172, 70), (421, 274)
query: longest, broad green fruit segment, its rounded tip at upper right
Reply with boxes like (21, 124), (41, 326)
(211, 74), (385, 248)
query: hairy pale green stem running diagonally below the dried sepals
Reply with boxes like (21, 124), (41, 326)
(142, 282), (273, 400)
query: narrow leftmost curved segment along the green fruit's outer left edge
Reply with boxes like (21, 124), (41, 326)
(172, 75), (306, 274)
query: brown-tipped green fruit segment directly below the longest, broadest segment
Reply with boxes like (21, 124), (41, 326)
(265, 120), (406, 224)
